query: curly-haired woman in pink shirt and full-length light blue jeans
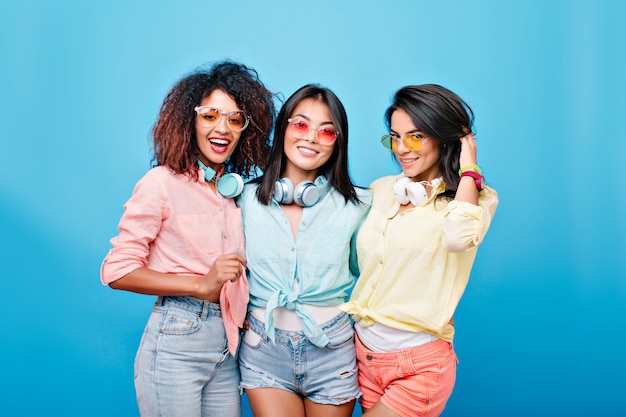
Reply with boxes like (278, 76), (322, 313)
(101, 61), (275, 417)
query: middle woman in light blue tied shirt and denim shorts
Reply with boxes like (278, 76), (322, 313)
(238, 84), (371, 417)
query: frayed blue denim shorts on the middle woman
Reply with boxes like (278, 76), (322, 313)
(239, 313), (361, 405)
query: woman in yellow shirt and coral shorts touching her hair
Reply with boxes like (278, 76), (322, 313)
(343, 84), (498, 417)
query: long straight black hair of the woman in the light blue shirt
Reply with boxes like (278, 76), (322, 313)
(257, 84), (359, 205)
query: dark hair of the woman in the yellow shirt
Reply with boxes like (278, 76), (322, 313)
(385, 84), (474, 197)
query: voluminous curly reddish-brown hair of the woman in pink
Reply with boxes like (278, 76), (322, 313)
(152, 60), (276, 179)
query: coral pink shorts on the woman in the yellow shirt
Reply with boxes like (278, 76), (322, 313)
(355, 337), (457, 417)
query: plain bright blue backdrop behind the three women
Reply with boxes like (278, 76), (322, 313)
(0, 0), (626, 417)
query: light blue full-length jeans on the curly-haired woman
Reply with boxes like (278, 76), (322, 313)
(135, 297), (241, 417)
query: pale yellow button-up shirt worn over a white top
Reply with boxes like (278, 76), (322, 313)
(342, 176), (498, 341)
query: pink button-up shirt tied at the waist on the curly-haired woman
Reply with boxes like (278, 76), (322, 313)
(100, 166), (248, 354)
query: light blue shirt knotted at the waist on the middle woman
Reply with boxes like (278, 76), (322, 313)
(237, 184), (372, 347)
